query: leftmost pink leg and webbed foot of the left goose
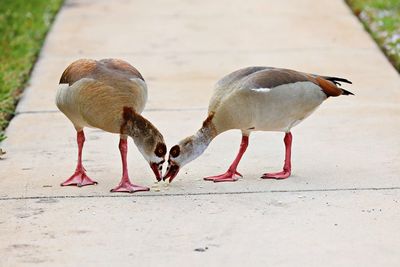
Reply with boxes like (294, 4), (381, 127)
(61, 130), (97, 187)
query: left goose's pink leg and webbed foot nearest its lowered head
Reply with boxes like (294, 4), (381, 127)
(111, 138), (150, 193)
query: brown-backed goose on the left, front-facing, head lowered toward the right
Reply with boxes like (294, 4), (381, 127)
(56, 59), (167, 193)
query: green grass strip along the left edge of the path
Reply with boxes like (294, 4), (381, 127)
(0, 0), (63, 142)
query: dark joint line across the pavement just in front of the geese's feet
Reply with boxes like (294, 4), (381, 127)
(0, 186), (400, 201)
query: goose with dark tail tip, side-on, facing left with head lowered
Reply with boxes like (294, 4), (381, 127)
(163, 67), (352, 182)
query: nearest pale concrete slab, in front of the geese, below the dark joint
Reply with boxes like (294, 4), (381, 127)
(0, 190), (400, 266)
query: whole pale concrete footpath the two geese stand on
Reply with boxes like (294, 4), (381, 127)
(0, 0), (400, 266)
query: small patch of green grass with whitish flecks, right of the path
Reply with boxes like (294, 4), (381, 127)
(346, 0), (400, 72)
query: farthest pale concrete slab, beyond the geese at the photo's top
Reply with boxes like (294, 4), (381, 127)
(42, 0), (375, 57)
